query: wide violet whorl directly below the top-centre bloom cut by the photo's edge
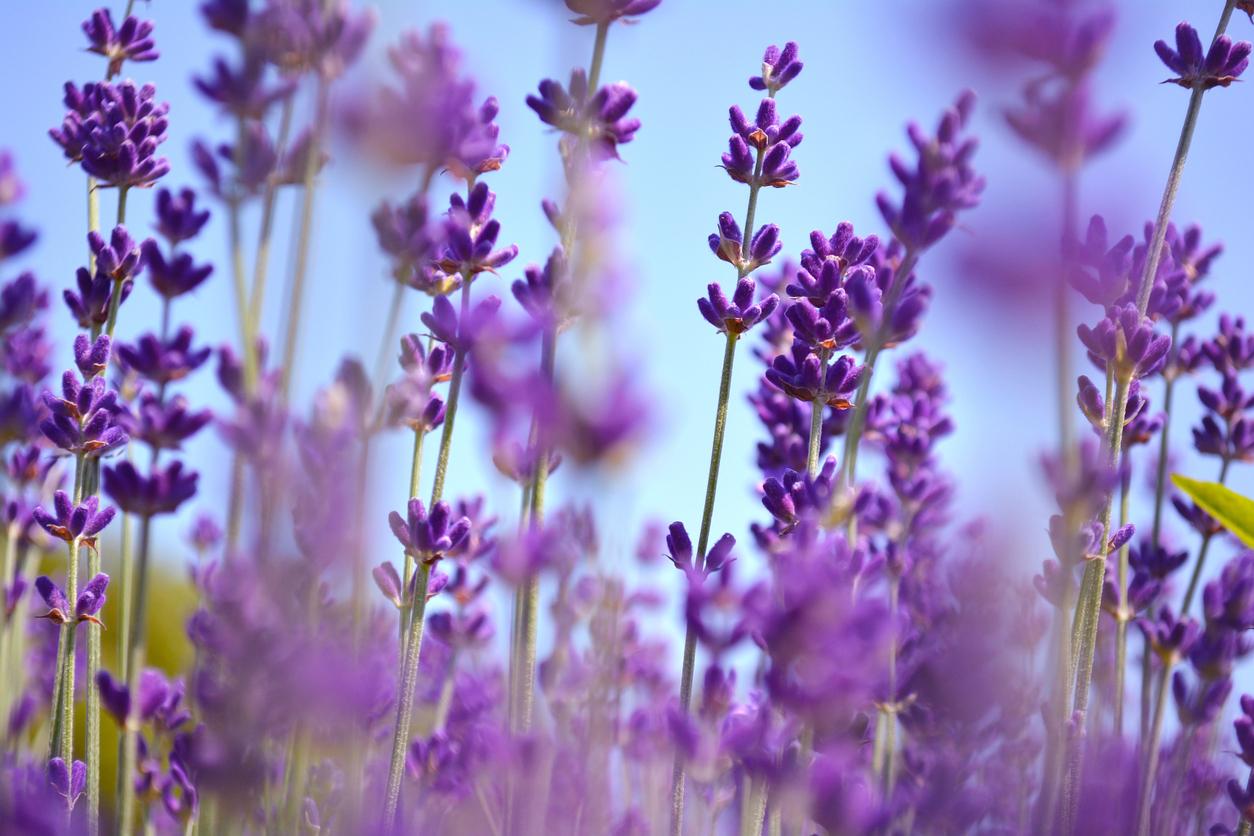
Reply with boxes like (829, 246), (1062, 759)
(527, 69), (640, 160)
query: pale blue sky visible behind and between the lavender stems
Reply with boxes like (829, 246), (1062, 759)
(0, 0), (1254, 671)
